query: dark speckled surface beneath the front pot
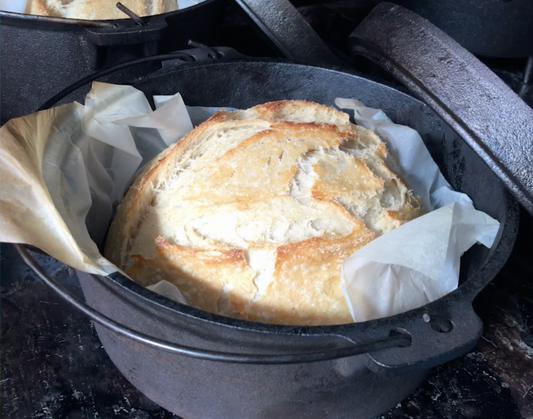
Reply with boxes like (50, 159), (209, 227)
(0, 210), (533, 419)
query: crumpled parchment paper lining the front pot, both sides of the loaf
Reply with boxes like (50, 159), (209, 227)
(0, 82), (499, 321)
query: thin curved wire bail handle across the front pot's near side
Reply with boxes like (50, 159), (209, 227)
(15, 244), (411, 364)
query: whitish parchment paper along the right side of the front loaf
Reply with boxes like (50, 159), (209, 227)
(335, 98), (500, 322)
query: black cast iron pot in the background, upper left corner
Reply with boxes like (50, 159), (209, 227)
(0, 0), (225, 123)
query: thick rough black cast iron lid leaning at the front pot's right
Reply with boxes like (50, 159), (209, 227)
(350, 3), (533, 214)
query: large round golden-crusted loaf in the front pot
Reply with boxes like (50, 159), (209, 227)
(105, 101), (423, 325)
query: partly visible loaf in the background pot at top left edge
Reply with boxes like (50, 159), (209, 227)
(25, 0), (178, 20)
